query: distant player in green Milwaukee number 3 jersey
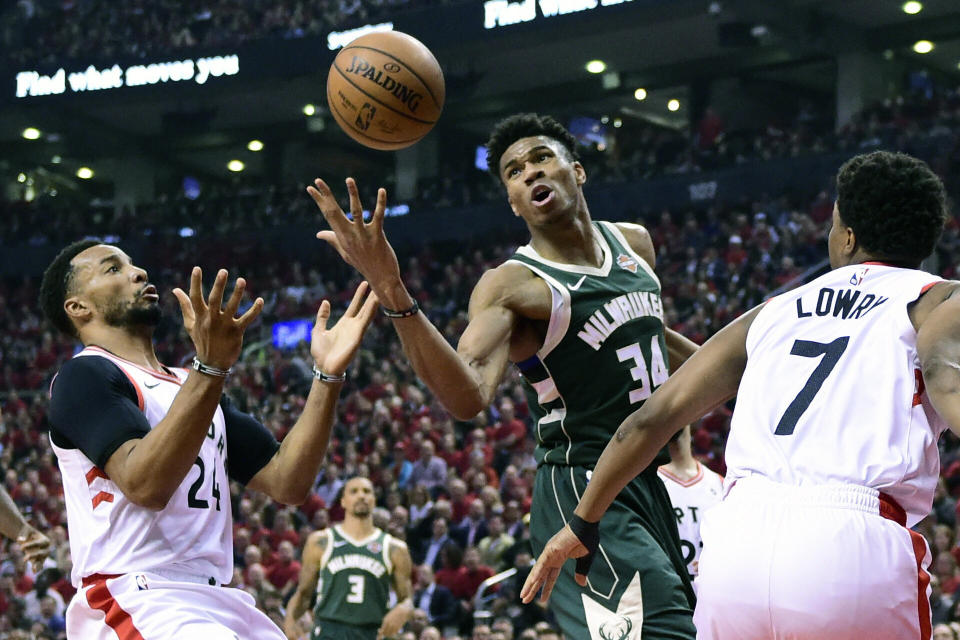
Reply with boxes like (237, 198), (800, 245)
(284, 477), (413, 640)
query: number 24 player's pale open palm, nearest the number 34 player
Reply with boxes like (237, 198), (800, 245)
(310, 281), (379, 376)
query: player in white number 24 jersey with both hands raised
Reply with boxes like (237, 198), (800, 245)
(40, 240), (377, 640)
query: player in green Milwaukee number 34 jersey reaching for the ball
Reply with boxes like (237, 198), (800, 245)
(307, 114), (696, 640)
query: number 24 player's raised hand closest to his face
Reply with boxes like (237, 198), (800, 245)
(173, 267), (263, 369)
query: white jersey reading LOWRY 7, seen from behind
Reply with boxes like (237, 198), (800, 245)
(726, 263), (946, 527)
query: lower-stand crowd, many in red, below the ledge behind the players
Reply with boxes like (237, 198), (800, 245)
(0, 171), (960, 640)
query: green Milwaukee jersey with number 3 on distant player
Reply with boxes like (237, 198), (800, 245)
(313, 526), (393, 627)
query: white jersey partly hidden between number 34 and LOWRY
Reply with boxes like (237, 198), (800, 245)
(657, 462), (723, 577)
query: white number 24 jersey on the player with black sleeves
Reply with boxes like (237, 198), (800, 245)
(53, 347), (233, 587)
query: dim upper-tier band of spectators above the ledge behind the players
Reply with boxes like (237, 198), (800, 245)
(0, 80), (960, 246)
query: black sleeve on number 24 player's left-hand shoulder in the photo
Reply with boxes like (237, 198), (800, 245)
(50, 356), (150, 469)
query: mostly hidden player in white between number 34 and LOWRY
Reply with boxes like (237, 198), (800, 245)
(657, 425), (723, 587)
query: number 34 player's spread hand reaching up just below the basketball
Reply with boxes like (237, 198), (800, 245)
(307, 178), (400, 304)
